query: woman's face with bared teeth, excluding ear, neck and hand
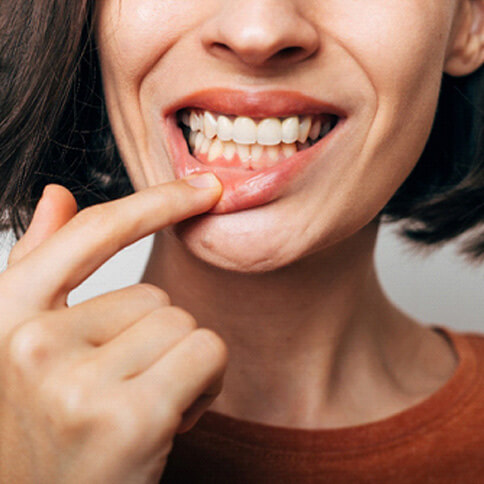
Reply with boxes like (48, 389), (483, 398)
(97, 0), (474, 272)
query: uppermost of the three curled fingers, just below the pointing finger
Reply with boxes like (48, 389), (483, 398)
(45, 284), (170, 346)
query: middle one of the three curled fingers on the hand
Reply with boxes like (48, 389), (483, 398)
(96, 306), (197, 380)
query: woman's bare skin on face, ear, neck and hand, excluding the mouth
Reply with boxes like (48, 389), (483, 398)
(0, 0), (484, 483)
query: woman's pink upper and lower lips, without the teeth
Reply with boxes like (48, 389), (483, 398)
(162, 88), (347, 214)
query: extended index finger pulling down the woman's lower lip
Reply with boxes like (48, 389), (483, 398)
(6, 173), (222, 309)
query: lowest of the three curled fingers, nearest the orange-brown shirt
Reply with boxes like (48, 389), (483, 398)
(130, 328), (228, 415)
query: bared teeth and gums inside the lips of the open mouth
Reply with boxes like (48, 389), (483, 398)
(176, 108), (339, 171)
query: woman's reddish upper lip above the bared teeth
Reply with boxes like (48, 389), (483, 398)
(163, 87), (347, 118)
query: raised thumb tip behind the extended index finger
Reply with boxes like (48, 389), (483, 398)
(8, 184), (77, 266)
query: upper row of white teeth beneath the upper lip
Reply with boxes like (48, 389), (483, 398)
(182, 110), (331, 146)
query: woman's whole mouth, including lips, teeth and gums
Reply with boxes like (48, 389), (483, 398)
(164, 89), (346, 214)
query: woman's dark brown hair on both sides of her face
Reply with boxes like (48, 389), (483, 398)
(0, 0), (484, 258)
